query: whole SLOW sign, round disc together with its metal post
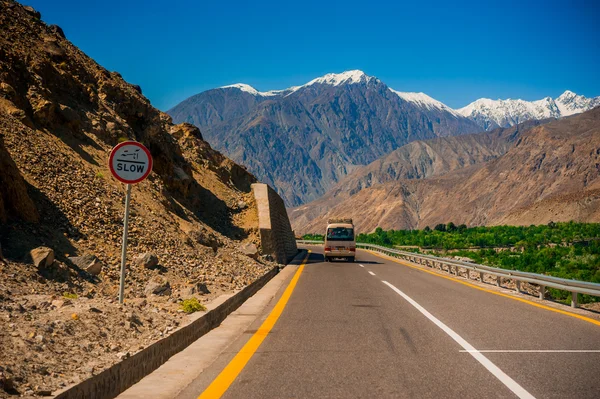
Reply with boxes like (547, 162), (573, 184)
(108, 141), (152, 304)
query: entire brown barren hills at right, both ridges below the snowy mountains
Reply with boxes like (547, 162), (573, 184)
(289, 108), (600, 234)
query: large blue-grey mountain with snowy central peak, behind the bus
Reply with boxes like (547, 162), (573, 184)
(168, 71), (480, 206)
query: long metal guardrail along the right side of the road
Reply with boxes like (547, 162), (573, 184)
(296, 240), (600, 308)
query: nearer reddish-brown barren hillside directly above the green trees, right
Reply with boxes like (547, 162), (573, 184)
(291, 109), (600, 233)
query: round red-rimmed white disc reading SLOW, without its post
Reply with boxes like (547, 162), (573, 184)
(108, 141), (152, 184)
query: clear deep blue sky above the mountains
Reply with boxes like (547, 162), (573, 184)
(25, 0), (600, 110)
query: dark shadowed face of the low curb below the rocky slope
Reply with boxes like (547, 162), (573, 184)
(55, 262), (286, 399)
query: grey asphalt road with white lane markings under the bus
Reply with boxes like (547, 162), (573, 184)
(179, 247), (600, 399)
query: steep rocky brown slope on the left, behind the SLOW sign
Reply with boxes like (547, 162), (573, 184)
(0, 1), (274, 397)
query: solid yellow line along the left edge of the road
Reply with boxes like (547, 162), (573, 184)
(198, 250), (310, 399)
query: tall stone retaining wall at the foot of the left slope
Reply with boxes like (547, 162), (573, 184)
(252, 183), (298, 264)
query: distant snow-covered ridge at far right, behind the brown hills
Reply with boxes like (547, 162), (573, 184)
(456, 90), (600, 130)
